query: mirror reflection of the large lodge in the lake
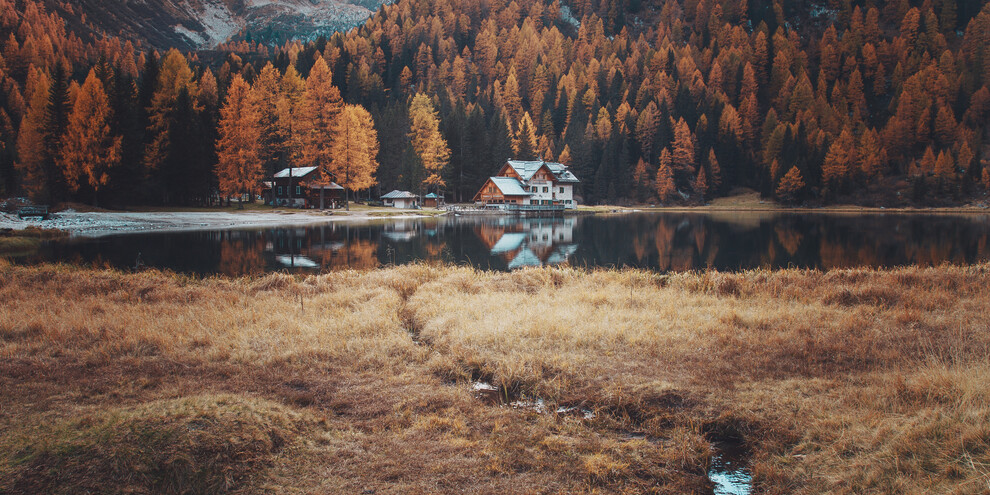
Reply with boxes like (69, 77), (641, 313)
(475, 217), (577, 269)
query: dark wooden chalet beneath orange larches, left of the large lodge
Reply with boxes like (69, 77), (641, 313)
(261, 167), (344, 208)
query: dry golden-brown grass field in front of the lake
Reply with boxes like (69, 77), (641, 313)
(0, 261), (990, 494)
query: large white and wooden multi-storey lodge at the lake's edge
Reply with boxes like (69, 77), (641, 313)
(474, 160), (580, 209)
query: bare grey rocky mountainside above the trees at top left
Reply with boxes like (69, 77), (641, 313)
(52, 0), (387, 50)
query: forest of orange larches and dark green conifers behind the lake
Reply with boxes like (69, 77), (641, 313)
(0, 0), (990, 204)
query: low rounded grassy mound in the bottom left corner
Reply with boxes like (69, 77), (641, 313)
(0, 395), (316, 494)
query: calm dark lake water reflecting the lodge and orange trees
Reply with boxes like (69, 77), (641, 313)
(14, 212), (990, 275)
